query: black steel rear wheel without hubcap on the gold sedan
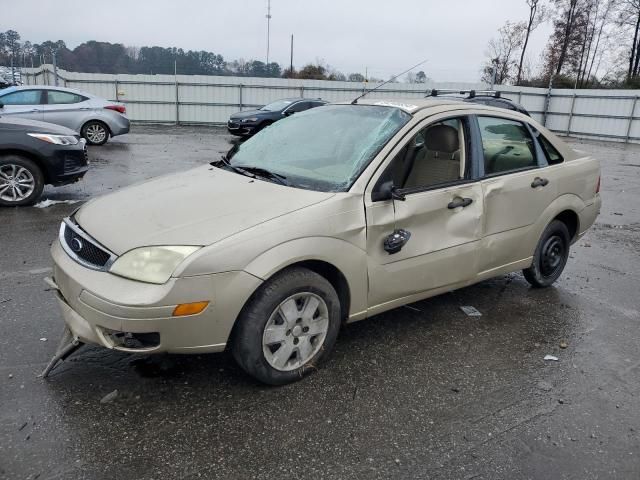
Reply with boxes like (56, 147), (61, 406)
(522, 220), (571, 288)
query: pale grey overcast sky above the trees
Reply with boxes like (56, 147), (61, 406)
(5, 0), (550, 81)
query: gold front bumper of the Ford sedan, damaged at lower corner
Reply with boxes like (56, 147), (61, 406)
(50, 240), (261, 353)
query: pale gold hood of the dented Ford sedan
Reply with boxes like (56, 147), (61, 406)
(75, 166), (334, 255)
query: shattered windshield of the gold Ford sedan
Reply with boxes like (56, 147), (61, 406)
(227, 105), (411, 192)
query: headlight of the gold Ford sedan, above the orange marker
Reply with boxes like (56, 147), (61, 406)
(109, 246), (200, 284)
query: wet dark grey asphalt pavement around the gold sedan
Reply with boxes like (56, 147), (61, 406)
(0, 126), (640, 479)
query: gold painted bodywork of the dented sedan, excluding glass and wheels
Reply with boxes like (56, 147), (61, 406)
(51, 100), (600, 353)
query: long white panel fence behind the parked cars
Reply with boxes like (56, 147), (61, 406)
(22, 65), (640, 142)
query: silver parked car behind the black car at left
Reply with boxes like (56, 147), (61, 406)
(0, 85), (129, 145)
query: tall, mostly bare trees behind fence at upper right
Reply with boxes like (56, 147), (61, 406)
(482, 0), (640, 88)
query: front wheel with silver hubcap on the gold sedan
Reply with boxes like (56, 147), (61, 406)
(231, 267), (341, 385)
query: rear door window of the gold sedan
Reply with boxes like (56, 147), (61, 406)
(478, 117), (538, 175)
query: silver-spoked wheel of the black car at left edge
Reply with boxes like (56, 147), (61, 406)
(0, 155), (44, 207)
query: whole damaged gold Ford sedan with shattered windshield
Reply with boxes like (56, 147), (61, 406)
(46, 99), (600, 384)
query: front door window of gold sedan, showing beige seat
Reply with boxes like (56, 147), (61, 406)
(385, 118), (465, 189)
